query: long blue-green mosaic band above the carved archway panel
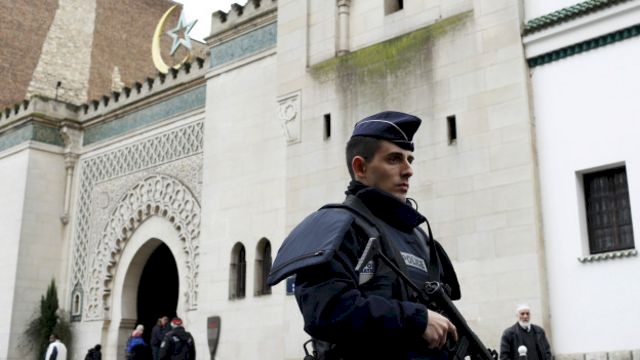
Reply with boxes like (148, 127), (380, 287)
(83, 86), (206, 145)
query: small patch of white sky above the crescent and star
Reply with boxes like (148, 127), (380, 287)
(174, 0), (240, 41)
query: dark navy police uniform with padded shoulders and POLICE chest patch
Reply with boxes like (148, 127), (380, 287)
(269, 182), (460, 359)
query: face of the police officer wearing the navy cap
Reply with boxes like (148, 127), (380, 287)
(354, 140), (413, 201)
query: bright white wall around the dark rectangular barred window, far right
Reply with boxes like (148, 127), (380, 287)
(531, 38), (640, 354)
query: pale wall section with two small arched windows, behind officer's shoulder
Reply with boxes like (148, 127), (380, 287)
(201, 49), (288, 359)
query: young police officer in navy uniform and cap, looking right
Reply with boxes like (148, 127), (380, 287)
(268, 111), (460, 360)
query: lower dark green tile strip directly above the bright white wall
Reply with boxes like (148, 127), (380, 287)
(527, 25), (640, 68)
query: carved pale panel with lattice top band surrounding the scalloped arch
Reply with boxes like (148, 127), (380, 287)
(71, 121), (203, 318)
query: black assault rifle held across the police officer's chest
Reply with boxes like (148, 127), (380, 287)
(356, 237), (498, 360)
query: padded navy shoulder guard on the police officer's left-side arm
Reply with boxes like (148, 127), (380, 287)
(267, 209), (354, 286)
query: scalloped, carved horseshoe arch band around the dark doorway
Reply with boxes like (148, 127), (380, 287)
(85, 175), (200, 320)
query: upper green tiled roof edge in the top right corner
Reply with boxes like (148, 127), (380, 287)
(523, 0), (629, 35)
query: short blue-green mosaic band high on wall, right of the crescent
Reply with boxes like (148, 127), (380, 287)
(209, 22), (278, 68)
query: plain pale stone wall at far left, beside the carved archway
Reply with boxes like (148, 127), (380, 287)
(0, 145), (68, 359)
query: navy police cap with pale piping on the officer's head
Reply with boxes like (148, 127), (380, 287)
(351, 111), (422, 151)
